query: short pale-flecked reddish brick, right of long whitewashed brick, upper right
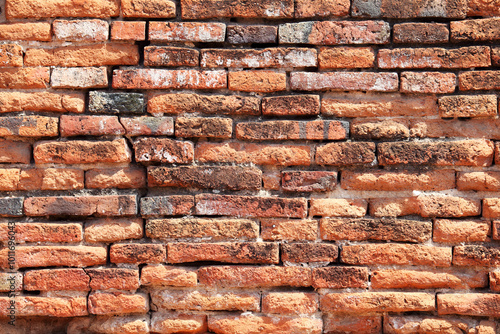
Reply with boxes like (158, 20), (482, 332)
(401, 72), (457, 94)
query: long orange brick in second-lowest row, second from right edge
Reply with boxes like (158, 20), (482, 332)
(320, 292), (435, 314)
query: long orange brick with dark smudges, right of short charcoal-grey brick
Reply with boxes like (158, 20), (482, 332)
(148, 93), (260, 115)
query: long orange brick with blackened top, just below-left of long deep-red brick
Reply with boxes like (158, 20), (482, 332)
(146, 218), (259, 241)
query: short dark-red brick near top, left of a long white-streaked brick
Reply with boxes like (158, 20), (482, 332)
(144, 46), (200, 67)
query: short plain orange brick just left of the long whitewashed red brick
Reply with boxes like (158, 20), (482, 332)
(228, 70), (286, 93)
